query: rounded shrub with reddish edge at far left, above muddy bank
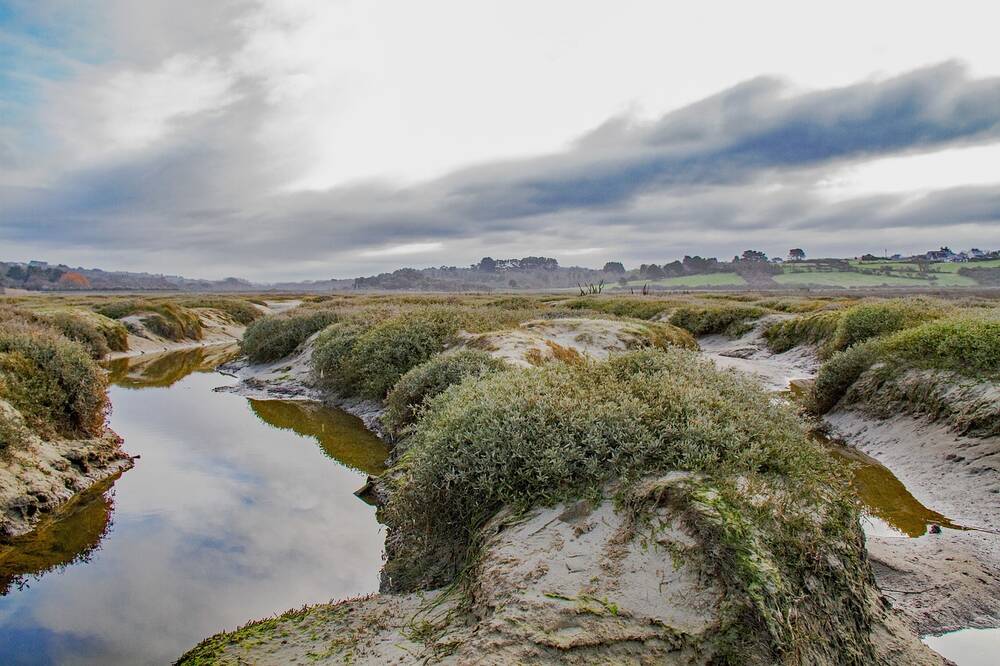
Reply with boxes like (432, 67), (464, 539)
(0, 321), (108, 438)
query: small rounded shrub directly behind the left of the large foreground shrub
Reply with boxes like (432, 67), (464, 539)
(382, 349), (507, 436)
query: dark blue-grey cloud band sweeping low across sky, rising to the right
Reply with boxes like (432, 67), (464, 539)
(0, 64), (1000, 276)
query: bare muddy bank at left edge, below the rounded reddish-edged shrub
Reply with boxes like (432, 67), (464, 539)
(0, 401), (133, 541)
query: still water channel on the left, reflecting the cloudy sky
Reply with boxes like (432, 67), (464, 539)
(0, 348), (387, 665)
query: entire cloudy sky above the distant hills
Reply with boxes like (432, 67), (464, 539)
(0, 0), (1000, 281)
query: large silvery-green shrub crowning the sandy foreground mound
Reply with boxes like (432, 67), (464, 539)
(382, 349), (830, 589)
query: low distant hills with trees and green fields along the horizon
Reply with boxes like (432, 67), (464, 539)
(0, 248), (1000, 293)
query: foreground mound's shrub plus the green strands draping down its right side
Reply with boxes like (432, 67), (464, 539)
(380, 348), (873, 663)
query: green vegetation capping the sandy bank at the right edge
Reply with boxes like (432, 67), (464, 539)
(812, 317), (1000, 414)
